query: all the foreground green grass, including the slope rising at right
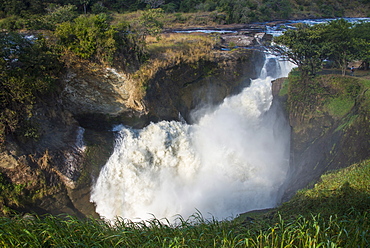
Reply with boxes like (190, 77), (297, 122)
(0, 160), (370, 247)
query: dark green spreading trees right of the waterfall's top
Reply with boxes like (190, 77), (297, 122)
(272, 19), (370, 75)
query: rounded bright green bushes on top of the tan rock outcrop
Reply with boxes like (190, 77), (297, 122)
(54, 13), (146, 68)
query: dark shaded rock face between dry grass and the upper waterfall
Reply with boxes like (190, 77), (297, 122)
(145, 50), (264, 122)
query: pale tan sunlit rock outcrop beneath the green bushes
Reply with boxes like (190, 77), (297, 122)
(61, 64), (143, 116)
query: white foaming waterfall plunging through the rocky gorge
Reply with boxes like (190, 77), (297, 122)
(91, 55), (292, 221)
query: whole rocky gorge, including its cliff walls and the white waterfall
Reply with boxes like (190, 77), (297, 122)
(1, 18), (370, 219)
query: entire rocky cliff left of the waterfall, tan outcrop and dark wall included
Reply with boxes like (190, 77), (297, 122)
(0, 45), (263, 216)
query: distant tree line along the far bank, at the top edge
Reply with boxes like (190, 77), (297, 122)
(0, 0), (370, 23)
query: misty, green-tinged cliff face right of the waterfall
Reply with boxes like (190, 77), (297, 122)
(284, 76), (370, 200)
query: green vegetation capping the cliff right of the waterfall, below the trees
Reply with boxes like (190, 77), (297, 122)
(286, 69), (369, 120)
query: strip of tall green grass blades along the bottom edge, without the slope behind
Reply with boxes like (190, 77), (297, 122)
(0, 212), (370, 247)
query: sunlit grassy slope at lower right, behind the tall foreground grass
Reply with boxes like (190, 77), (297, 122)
(280, 160), (370, 218)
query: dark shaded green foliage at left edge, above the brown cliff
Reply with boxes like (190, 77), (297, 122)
(0, 33), (60, 146)
